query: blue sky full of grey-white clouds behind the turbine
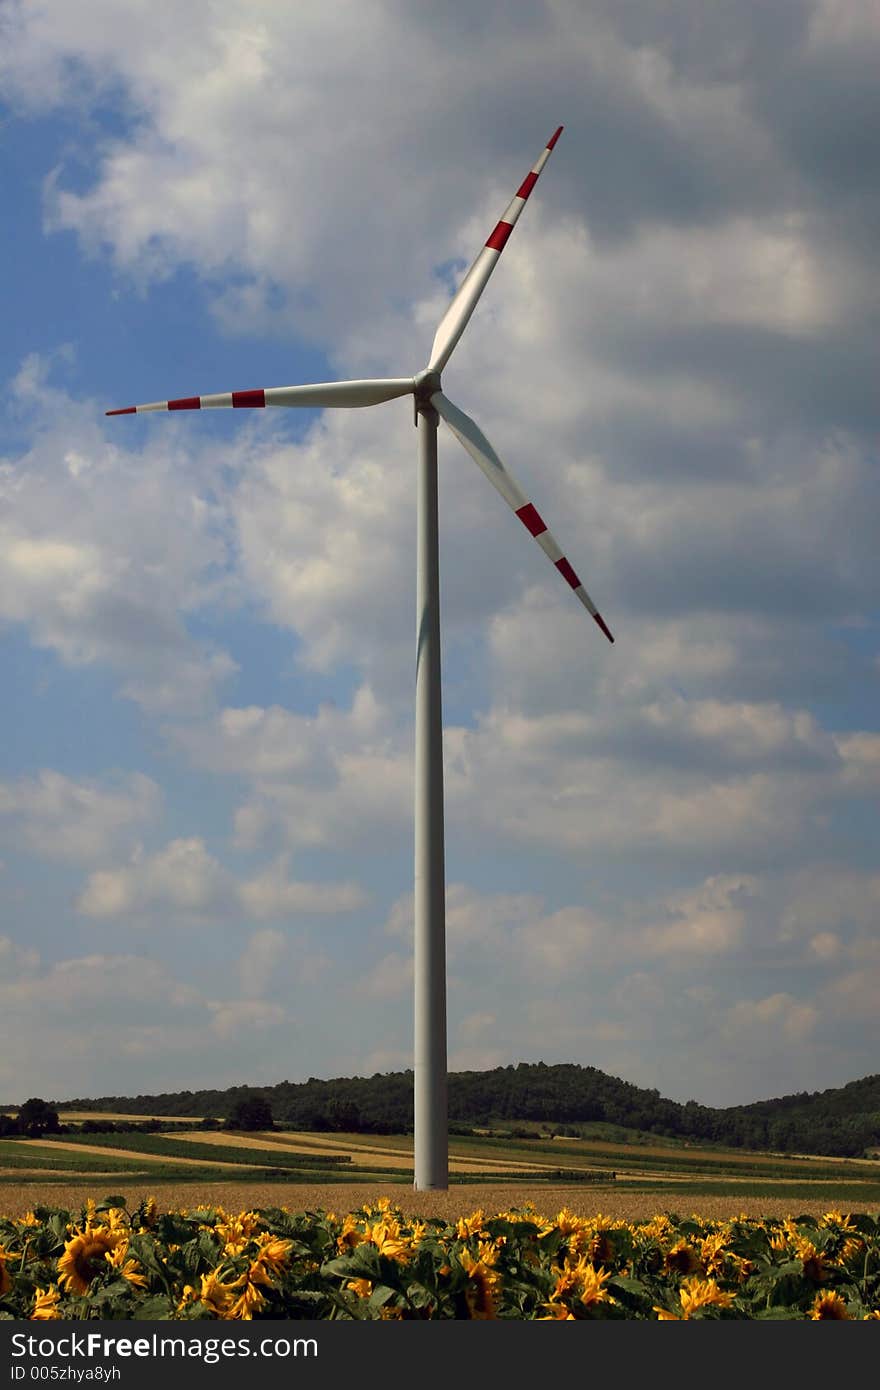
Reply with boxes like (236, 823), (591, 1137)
(0, 0), (880, 1105)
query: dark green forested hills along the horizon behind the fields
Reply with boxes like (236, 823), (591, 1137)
(53, 1062), (880, 1156)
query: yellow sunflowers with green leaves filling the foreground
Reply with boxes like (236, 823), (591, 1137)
(0, 1197), (880, 1322)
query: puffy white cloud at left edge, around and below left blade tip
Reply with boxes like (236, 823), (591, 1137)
(0, 357), (236, 713)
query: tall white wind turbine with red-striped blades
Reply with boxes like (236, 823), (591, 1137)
(107, 125), (614, 1190)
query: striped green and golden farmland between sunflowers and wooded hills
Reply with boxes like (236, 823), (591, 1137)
(0, 1115), (880, 1220)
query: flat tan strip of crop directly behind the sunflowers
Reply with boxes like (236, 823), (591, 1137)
(0, 1175), (877, 1220)
